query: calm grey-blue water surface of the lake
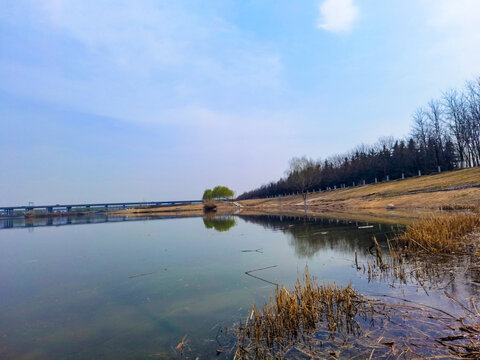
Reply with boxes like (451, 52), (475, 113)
(0, 216), (474, 359)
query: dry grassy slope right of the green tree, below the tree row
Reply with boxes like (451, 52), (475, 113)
(240, 167), (480, 218)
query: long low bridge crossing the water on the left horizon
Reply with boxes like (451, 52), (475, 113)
(0, 200), (203, 216)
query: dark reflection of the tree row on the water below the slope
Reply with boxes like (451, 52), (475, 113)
(239, 215), (395, 258)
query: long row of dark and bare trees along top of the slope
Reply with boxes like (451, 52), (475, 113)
(239, 78), (480, 200)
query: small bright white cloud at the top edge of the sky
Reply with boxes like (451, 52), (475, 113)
(317, 0), (359, 32)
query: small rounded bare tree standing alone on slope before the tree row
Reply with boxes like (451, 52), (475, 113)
(286, 156), (320, 208)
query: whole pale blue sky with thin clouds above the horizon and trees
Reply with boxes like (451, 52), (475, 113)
(0, 0), (480, 206)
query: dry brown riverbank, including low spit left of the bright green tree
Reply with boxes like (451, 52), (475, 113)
(109, 167), (480, 224)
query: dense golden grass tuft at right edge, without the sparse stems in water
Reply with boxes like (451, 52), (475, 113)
(396, 214), (480, 254)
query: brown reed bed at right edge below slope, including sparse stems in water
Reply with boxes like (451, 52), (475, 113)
(362, 214), (480, 292)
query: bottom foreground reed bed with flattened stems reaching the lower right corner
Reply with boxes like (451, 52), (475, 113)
(232, 269), (480, 360)
